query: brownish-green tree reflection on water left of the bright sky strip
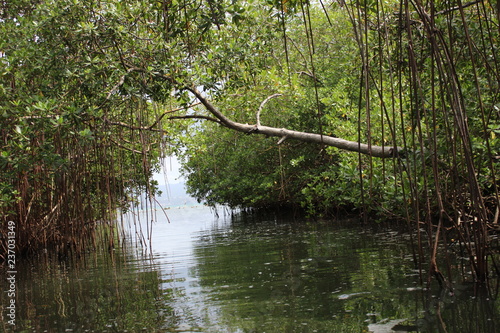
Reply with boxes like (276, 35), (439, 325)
(11, 241), (178, 332)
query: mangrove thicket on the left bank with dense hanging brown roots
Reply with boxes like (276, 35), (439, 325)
(0, 1), (188, 253)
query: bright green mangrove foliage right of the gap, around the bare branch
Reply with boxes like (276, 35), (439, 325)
(181, 2), (499, 218)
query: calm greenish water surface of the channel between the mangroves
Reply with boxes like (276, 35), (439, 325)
(0, 201), (500, 333)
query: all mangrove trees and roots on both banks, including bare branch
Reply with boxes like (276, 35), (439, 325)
(0, 0), (500, 288)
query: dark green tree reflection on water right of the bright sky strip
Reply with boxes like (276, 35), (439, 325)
(193, 215), (496, 332)
